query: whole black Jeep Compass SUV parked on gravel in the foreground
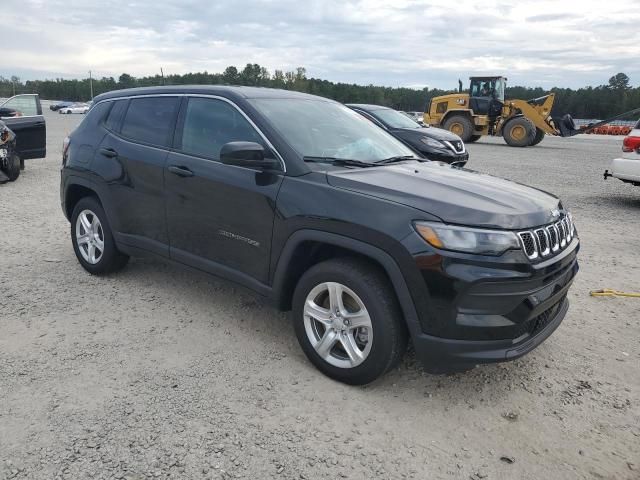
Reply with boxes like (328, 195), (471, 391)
(60, 86), (579, 384)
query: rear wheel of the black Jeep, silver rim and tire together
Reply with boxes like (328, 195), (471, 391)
(71, 197), (129, 275)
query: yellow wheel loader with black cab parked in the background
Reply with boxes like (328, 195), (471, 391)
(424, 77), (582, 147)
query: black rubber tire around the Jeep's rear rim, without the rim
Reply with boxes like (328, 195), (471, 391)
(71, 197), (129, 275)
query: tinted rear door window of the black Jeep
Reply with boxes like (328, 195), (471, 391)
(121, 97), (179, 147)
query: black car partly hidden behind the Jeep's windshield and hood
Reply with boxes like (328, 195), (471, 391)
(347, 103), (469, 167)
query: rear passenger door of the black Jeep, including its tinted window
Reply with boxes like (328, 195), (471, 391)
(92, 96), (180, 256)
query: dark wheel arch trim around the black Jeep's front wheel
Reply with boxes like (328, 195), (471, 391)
(272, 230), (421, 335)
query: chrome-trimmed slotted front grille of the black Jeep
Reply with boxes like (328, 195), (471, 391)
(518, 213), (576, 260)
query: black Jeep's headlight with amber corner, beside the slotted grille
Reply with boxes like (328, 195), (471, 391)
(414, 222), (520, 255)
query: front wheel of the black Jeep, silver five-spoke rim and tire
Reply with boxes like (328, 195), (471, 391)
(293, 258), (407, 385)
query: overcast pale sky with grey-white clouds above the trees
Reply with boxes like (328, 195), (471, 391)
(0, 0), (640, 88)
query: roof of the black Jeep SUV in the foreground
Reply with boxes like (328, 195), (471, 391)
(94, 85), (333, 102)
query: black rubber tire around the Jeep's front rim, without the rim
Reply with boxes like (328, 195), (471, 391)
(292, 258), (408, 385)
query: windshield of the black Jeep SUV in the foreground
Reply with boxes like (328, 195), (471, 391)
(250, 98), (415, 163)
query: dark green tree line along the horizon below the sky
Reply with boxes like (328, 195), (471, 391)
(0, 64), (640, 118)
